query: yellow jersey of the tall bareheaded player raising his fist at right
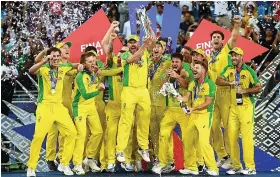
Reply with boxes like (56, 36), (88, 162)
(208, 43), (231, 84)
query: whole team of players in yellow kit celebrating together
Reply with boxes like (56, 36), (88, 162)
(27, 17), (261, 177)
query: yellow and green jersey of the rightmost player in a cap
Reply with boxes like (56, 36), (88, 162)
(221, 64), (260, 105)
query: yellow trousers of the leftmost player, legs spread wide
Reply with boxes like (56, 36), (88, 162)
(28, 103), (77, 169)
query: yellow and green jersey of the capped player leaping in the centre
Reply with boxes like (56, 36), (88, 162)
(121, 50), (150, 88)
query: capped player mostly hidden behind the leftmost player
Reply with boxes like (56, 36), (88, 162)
(35, 42), (82, 171)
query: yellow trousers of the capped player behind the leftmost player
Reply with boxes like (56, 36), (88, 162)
(46, 100), (73, 161)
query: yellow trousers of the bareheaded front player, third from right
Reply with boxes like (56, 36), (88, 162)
(182, 113), (218, 172)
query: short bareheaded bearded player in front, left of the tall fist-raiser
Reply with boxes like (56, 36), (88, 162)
(178, 60), (219, 176)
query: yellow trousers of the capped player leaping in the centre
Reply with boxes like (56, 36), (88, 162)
(116, 87), (151, 152)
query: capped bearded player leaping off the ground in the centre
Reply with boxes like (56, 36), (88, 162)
(116, 30), (155, 162)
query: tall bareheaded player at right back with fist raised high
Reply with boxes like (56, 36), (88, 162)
(208, 16), (241, 169)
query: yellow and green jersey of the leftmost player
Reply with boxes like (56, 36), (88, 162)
(38, 63), (73, 103)
